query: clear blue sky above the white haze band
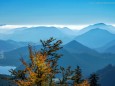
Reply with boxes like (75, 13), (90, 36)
(0, 0), (115, 25)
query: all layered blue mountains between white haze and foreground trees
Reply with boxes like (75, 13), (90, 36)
(0, 23), (115, 80)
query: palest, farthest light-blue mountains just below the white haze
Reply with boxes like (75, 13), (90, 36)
(0, 23), (115, 48)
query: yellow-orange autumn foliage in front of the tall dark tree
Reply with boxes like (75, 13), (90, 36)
(17, 47), (51, 86)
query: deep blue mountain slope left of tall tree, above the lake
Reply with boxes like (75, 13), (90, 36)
(0, 45), (41, 67)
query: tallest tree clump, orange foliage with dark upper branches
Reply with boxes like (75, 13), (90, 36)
(10, 38), (62, 86)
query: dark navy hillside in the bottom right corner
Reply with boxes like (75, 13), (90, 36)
(97, 65), (115, 86)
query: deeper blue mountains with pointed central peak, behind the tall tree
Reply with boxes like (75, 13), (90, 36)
(0, 41), (115, 76)
